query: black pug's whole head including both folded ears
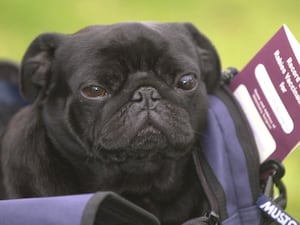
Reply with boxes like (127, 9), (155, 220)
(21, 23), (220, 167)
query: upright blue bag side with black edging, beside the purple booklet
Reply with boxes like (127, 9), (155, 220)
(194, 83), (260, 225)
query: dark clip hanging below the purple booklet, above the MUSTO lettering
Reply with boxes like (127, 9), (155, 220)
(260, 160), (287, 209)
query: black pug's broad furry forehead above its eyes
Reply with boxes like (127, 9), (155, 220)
(54, 23), (196, 81)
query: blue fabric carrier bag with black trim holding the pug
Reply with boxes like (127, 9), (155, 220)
(0, 67), (285, 225)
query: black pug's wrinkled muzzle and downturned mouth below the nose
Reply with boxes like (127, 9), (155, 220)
(93, 100), (195, 162)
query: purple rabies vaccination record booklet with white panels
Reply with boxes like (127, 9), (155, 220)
(230, 25), (300, 162)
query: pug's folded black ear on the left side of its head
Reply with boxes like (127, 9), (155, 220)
(20, 33), (63, 101)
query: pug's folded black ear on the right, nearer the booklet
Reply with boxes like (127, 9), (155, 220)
(184, 23), (221, 93)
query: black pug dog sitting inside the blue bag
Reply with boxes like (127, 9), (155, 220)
(2, 23), (220, 225)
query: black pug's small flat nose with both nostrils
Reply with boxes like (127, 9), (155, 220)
(131, 87), (161, 109)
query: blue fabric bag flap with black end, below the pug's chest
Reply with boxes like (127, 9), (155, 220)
(0, 192), (160, 225)
